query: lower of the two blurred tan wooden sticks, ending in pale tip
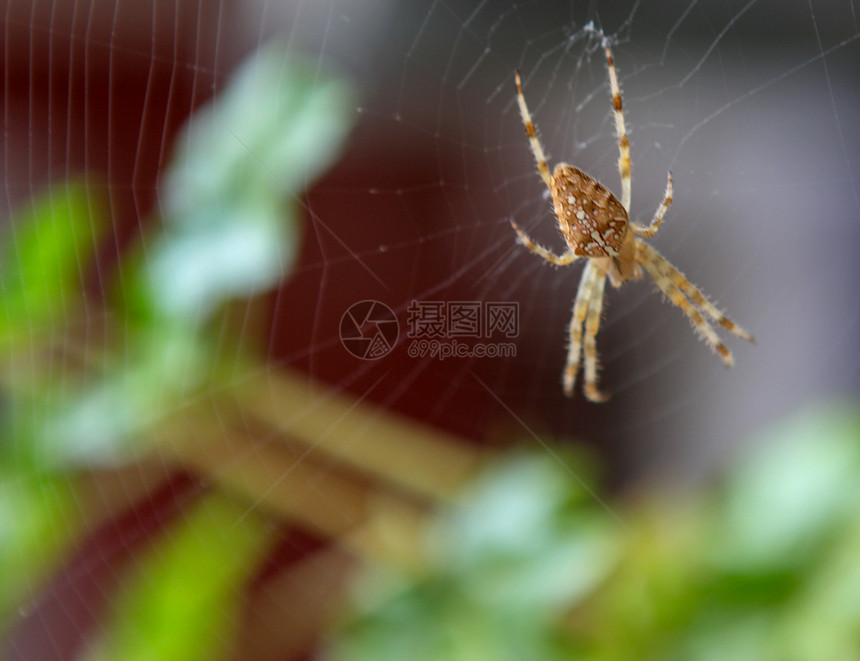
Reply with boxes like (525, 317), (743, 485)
(158, 415), (431, 568)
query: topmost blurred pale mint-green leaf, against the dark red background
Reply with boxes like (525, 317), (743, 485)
(164, 42), (352, 214)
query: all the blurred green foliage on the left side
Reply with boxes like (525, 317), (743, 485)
(0, 40), (351, 648)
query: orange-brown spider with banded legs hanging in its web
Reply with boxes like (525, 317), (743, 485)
(511, 39), (755, 402)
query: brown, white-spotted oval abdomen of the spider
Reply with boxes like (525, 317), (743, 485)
(550, 163), (628, 257)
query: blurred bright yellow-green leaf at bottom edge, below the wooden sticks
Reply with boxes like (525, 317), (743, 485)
(91, 492), (270, 661)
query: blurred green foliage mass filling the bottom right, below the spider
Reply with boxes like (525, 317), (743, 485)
(328, 407), (860, 661)
